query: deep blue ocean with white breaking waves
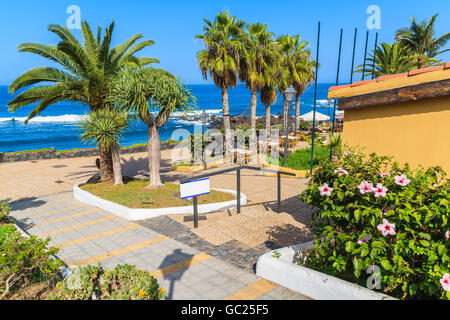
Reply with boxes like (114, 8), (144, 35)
(0, 83), (333, 152)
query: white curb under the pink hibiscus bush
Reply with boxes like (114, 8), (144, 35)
(256, 241), (397, 300)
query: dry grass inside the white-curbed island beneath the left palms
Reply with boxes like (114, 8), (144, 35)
(81, 177), (236, 209)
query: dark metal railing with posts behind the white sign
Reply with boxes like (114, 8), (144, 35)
(180, 166), (295, 228)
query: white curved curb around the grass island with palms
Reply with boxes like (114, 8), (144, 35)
(73, 183), (247, 221)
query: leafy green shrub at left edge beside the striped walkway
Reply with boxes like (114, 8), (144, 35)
(0, 232), (63, 299)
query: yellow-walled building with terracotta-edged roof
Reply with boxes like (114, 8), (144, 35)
(328, 63), (450, 174)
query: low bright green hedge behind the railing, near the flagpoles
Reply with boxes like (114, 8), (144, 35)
(267, 146), (330, 170)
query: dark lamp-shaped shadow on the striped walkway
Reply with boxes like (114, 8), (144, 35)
(159, 249), (194, 300)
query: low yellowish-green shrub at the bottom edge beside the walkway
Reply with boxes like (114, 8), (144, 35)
(48, 264), (165, 300)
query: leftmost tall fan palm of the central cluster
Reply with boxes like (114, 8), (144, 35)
(195, 11), (244, 159)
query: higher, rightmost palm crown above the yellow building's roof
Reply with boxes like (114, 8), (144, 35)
(396, 14), (450, 69)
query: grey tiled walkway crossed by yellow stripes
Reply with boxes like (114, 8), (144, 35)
(11, 192), (308, 300)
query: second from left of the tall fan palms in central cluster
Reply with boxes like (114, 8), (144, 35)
(239, 23), (279, 129)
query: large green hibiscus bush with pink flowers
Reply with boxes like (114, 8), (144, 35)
(301, 150), (450, 299)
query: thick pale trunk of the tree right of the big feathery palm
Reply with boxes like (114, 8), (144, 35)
(147, 125), (164, 188)
